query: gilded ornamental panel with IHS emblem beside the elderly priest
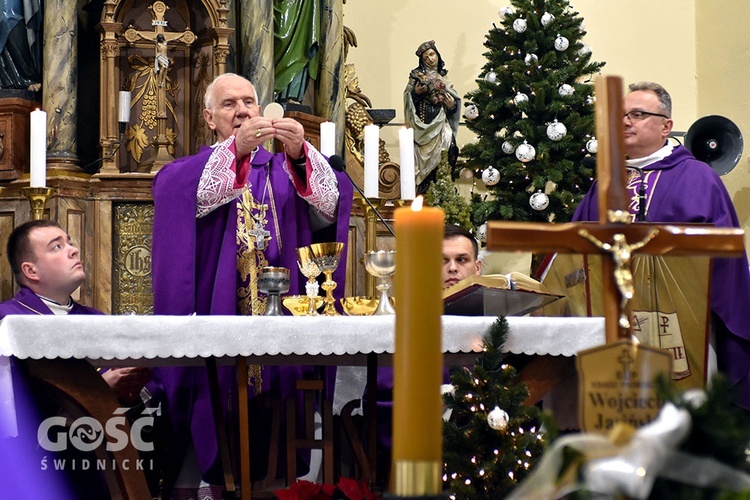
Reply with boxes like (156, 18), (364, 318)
(112, 203), (154, 314)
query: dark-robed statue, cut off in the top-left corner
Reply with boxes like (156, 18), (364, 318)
(0, 0), (43, 91)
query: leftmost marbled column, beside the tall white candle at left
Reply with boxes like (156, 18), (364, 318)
(42, 0), (78, 170)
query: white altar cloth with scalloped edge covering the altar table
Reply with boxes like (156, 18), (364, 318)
(0, 315), (605, 497)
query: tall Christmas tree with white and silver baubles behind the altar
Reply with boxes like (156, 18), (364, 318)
(462, 0), (603, 226)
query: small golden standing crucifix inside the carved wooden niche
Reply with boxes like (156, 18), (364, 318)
(125, 1), (195, 172)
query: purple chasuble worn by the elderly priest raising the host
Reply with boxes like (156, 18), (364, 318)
(152, 146), (353, 484)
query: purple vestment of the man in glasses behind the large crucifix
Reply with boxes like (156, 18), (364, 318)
(573, 146), (750, 410)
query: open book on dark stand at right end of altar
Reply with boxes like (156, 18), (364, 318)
(443, 272), (562, 316)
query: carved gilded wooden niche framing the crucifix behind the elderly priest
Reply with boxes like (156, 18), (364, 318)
(98, 0), (233, 176)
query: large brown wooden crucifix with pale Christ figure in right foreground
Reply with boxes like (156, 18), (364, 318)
(487, 76), (744, 343)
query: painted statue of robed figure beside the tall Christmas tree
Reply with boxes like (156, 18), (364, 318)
(404, 40), (461, 193)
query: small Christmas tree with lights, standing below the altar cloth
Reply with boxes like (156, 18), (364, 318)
(443, 318), (544, 498)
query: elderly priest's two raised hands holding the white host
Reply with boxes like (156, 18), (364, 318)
(234, 116), (305, 159)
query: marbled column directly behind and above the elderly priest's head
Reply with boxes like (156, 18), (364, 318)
(237, 0), (274, 104)
